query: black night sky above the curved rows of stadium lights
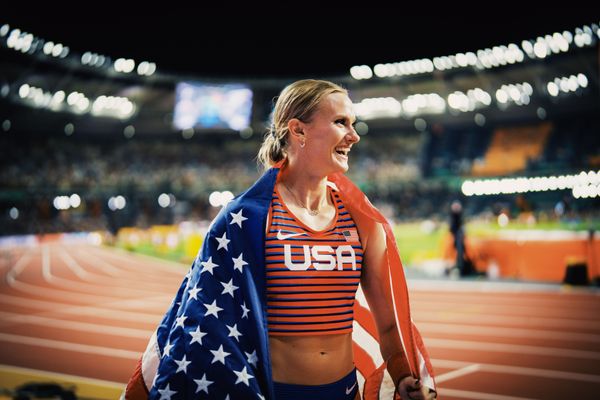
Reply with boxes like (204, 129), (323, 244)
(0, 12), (599, 79)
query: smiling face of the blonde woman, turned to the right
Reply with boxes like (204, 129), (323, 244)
(297, 93), (360, 176)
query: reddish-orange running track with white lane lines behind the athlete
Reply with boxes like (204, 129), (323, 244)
(0, 243), (600, 400)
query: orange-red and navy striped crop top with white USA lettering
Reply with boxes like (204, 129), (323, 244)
(265, 187), (363, 336)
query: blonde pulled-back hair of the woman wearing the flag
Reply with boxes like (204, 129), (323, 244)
(257, 79), (348, 169)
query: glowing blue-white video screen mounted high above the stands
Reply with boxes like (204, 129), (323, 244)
(173, 82), (252, 131)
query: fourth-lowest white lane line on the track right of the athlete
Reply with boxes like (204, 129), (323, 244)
(411, 303), (600, 330)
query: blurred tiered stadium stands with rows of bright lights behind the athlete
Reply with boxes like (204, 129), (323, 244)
(0, 18), (600, 239)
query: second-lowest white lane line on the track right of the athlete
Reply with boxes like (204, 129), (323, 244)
(431, 359), (600, 383)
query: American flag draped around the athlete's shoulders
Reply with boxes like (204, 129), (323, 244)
(124, 166), (434, 400)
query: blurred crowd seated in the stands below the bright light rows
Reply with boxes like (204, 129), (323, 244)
(0, 114), (600, 234)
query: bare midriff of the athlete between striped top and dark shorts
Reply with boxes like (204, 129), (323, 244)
(269, 333), (354, 385)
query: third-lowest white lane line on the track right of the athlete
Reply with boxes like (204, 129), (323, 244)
(425, 338), (600, 360)
